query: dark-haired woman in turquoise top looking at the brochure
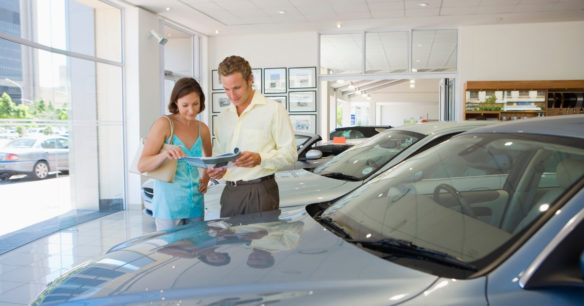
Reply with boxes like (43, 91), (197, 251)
(138, 78), (212, 230)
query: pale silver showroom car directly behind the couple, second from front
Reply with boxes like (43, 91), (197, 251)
(143, 121), (492, 220)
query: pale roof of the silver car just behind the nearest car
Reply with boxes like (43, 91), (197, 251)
(382, 120), (498, 135)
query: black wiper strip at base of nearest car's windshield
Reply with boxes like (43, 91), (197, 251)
(349, 238), (477, 271)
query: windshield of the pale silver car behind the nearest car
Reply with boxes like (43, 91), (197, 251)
(314, 130), (424, 180)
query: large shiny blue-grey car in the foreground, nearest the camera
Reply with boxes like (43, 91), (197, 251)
(36, 115), (584, 305)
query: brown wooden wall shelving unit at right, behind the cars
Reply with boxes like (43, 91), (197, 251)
(464, 80), (584, 120)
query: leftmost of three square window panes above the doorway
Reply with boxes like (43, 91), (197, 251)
(320, 34), (363, 74)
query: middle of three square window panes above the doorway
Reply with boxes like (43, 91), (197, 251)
(365, 32), (409, 73)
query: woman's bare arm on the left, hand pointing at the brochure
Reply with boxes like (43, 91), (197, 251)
(138, 117), (184, 172)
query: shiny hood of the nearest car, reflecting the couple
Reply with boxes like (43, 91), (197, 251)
(37, 210), (438, 305)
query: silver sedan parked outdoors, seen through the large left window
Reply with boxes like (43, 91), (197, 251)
(0, 136), (69, 180)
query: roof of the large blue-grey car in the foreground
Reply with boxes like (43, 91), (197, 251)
(465, 115), (584, 139)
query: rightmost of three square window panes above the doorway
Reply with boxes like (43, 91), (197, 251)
(412, 30), (458, 72)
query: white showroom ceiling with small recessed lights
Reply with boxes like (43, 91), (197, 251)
(123, 0), (584, 36)
